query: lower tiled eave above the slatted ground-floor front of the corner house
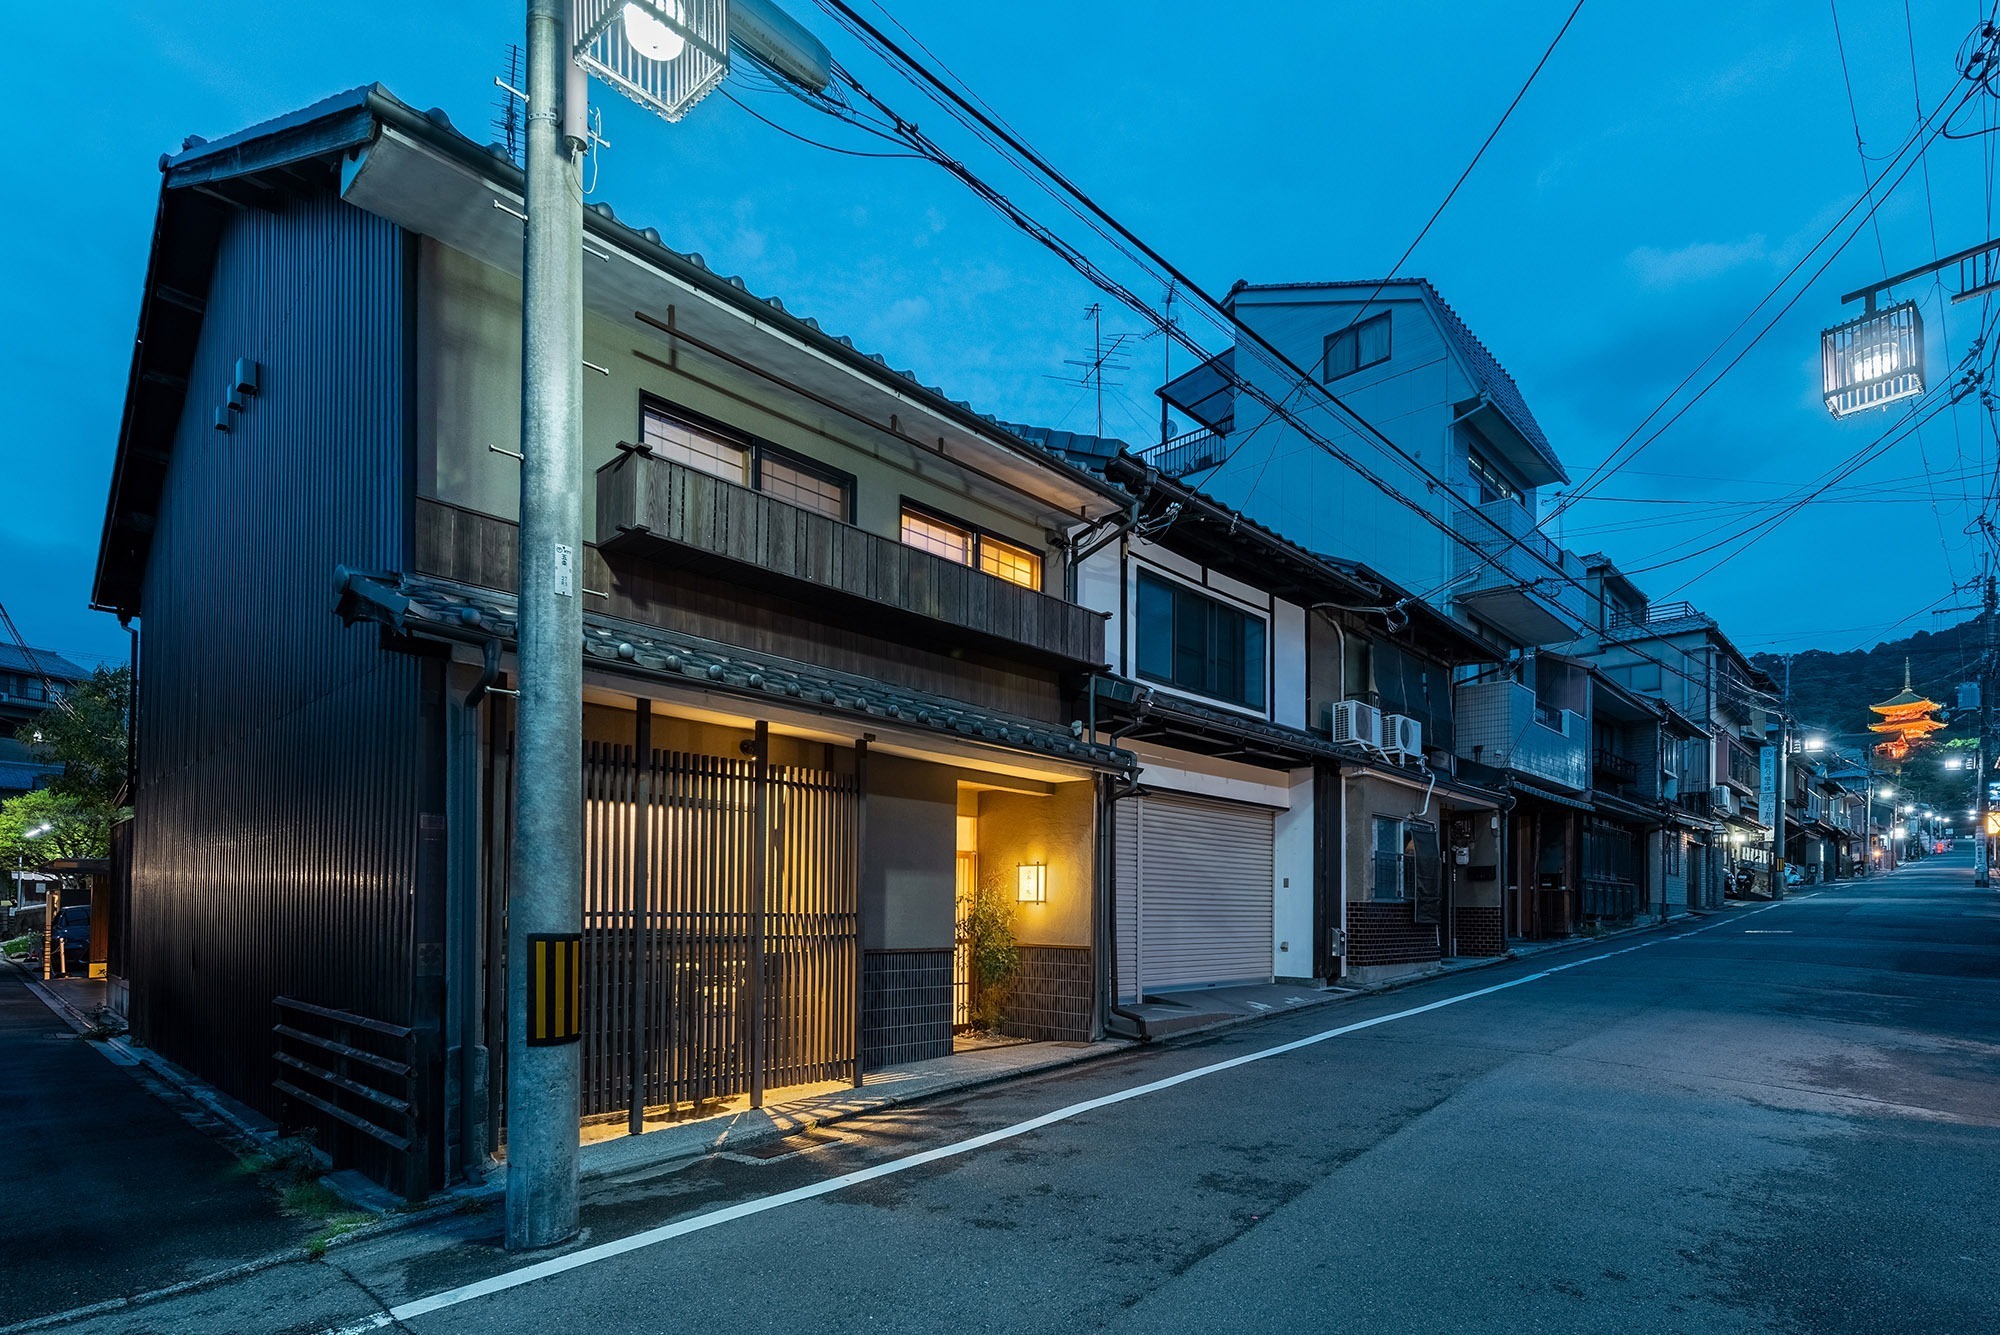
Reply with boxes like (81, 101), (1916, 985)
(340, 574), (1138, 771)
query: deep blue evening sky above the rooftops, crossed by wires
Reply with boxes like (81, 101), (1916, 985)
(0, 0), (1994, 658)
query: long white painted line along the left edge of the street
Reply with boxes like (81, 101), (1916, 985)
(326, 905), (1778, 1335)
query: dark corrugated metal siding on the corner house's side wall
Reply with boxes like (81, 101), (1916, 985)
(130, 196), (424, 1175)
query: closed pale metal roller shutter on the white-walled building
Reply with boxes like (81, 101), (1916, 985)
(1114, 793), (1276, 1001)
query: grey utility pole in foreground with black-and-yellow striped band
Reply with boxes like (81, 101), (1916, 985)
(506, 0), (584, 1249)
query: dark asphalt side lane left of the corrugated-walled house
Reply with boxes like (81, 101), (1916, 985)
(0, 965), (310, 1323)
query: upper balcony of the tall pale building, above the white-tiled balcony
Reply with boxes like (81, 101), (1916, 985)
(1452, 500), (1586, 644)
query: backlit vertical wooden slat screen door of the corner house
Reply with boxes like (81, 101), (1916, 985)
(580, 743), (860, 1119)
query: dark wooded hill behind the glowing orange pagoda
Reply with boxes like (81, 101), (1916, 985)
(1750, 618), (1980, 743)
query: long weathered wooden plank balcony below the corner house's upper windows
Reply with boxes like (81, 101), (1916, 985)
(598, 446), (1104, 666)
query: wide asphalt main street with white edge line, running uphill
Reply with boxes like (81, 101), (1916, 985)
(19, 855), (2000, 1335)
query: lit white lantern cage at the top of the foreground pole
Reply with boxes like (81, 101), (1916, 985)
(570, 0), (730, 120)
